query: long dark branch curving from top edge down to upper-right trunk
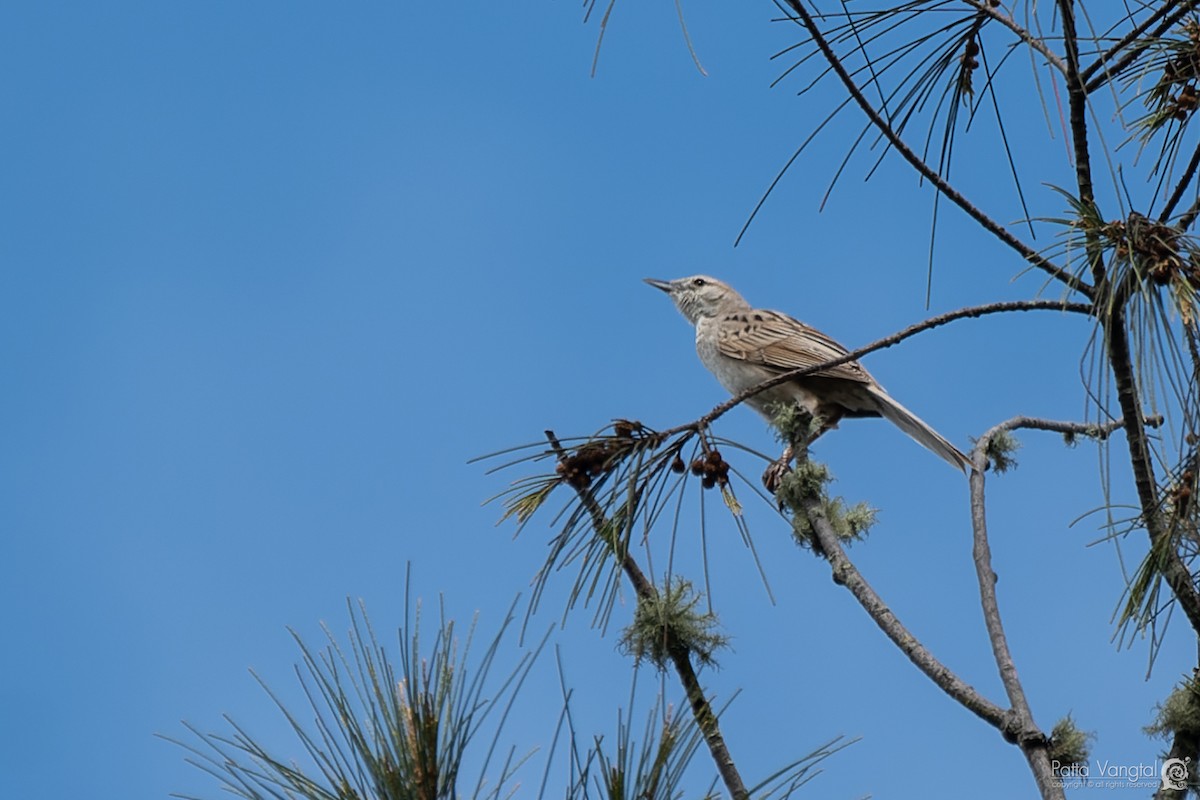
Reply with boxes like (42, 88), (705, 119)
(781, 0), (1093, 299)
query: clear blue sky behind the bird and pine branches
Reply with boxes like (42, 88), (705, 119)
(0, 1), (1194, 798)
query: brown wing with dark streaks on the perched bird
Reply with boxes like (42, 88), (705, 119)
(718, 309), (874, 384)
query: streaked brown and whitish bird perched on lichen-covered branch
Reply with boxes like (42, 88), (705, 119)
(646, 275), (971, 482)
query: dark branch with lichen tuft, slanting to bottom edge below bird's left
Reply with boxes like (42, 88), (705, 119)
(546, 431), (750, 800)
